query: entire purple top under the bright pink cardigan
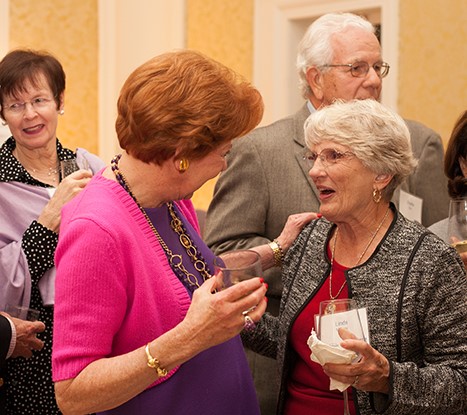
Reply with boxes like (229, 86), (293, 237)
(101, 204), (259, 415)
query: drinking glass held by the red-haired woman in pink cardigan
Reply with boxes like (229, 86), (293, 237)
(214, 249), (263, 288)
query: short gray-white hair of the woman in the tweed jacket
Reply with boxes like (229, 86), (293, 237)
(305, 99), (417, 201)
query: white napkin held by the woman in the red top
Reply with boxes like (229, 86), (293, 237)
(307, 330), (357, 392)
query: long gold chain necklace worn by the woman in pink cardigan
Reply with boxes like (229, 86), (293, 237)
(111, 154), (211, 287)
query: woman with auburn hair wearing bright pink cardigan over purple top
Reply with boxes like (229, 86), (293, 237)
(53, 50), (315, 415)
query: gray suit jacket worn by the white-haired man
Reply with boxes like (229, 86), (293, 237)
(205, 105), (449, 297)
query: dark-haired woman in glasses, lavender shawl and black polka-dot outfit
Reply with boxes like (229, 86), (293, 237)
(0, 50), (103, 414)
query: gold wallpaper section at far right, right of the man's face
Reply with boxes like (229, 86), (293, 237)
(398, 0), (467, 147)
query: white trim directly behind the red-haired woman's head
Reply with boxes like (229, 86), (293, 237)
(98, 0), (185, 162)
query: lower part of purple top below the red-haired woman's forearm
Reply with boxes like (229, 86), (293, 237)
(100, 336), (260, 415)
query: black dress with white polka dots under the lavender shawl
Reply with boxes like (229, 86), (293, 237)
(0, 137), (75, 415)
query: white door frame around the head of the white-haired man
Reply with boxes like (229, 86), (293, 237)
(253, 0), (399, 125)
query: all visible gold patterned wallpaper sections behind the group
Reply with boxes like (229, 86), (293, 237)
(5, 0), (467, 208)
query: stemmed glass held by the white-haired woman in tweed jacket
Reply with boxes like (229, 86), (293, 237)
(317, 298), (365, 415)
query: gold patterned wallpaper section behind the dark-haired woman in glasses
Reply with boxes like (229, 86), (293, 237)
(10, 0), (99, 153)
